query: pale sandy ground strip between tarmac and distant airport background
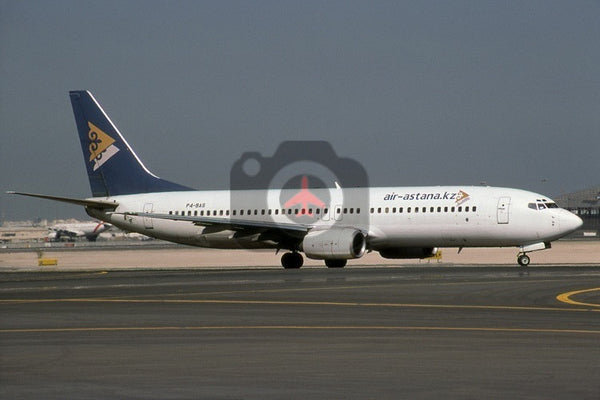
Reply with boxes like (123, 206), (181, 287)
(0, 241), (600, 271)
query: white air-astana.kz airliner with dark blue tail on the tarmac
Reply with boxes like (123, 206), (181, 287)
(8, 90), (583, 269)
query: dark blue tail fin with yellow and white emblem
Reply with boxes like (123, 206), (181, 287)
(69, 90), (192, 197)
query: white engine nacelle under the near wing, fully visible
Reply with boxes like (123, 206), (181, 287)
(302, 228), (367, 260)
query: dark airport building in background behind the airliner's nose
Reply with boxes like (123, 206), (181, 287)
(554, 186), (600, 238)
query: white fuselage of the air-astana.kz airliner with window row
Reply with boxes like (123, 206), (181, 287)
(88, 186), (581, 250)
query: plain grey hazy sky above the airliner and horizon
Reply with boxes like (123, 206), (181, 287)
(0, 0), (600, 220)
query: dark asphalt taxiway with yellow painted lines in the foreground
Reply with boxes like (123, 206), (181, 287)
(0, 266), (600, 399)
